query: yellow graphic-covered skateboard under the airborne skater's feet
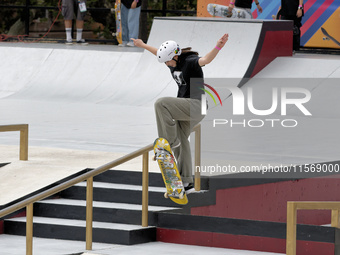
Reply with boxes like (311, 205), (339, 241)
(153, 138), (188, 205)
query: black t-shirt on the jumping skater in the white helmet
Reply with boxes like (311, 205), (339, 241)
(169, 52), (204, 100)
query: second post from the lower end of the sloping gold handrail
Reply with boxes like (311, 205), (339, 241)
(86, 177), (93, 250)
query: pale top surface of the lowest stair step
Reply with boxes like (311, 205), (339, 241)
(6, 216), (154, 231)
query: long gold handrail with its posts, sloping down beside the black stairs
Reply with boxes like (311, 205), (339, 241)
(0, 125), (201, 255)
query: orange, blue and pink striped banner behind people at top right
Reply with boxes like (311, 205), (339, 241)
(197, 0), (340, 49)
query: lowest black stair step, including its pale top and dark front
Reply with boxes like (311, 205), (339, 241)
(4, 217), (156, 245)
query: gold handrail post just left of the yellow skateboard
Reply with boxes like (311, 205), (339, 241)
(142, 152), (149, 227)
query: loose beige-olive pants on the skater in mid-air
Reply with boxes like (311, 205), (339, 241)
(155, 97), (204, 183)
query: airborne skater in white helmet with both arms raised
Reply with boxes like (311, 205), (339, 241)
(133, 34), (228, 194)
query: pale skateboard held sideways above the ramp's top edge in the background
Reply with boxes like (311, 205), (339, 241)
(207, 4), (252, 19)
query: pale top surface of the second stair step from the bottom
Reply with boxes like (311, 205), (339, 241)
(38, 198), (178, 211)
